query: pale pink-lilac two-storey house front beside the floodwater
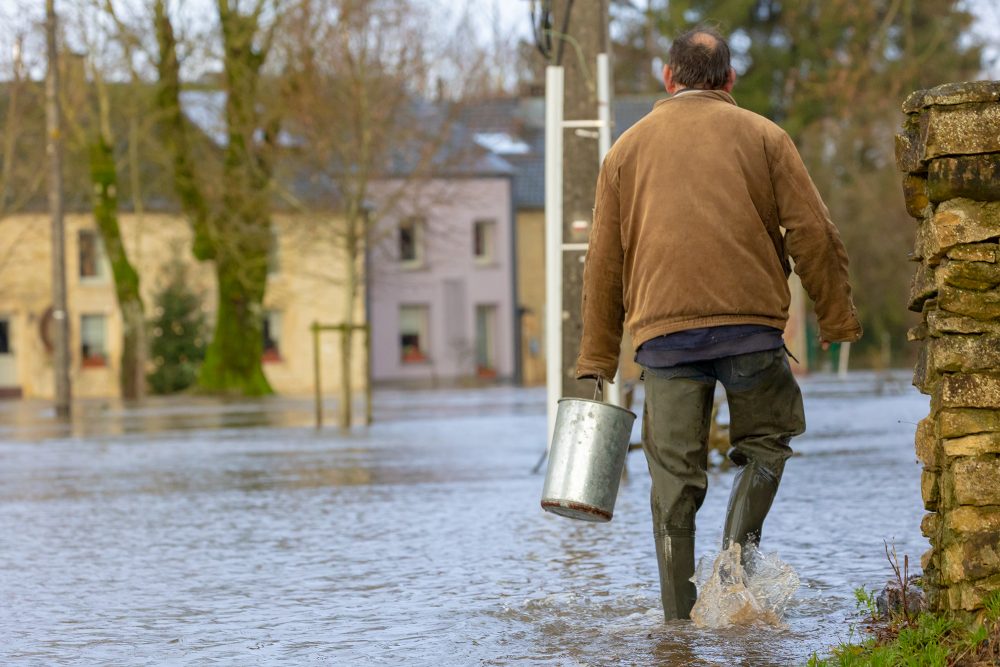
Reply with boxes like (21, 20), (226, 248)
(367, 170), (520, 384)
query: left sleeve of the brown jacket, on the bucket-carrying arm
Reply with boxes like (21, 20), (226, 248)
(576, 153), (625, 380)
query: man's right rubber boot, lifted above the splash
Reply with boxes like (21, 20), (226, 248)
(722, 461), (781, 566)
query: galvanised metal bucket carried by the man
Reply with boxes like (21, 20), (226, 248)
(542, 398), (635, 521)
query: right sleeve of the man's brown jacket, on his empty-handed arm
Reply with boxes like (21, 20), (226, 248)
(771, 132), (861, 342)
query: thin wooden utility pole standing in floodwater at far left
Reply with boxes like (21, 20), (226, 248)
(45, 0), (71, 418)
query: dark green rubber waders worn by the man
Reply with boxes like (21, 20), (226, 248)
(642, 348), (805, 620)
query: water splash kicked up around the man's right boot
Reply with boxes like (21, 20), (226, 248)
(691, 544), (799, 628)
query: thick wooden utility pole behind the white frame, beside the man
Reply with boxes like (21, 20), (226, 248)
(550, 0), (610, 398)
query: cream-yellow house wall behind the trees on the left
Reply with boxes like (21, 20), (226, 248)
(0, 214), (366, 398)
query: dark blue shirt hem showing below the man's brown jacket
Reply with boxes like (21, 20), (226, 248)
(635, 324), (785, 368)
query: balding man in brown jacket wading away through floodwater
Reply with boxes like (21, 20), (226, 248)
(577, 28), (861, 620)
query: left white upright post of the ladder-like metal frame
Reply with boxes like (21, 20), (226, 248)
(545, 66), (564, 447)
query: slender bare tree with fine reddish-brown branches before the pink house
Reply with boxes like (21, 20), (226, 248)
(279, 0), (496, 428)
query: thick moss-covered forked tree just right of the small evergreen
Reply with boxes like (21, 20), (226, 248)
(154, 0), (283, 395)
